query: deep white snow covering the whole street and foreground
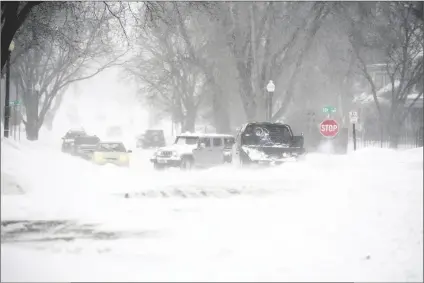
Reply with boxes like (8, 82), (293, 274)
(1, 141), (423, 281)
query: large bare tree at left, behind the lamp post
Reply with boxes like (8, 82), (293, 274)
(12, 3), (129, 140)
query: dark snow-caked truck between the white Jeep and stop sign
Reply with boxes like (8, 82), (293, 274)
(232, 122), (305, 166)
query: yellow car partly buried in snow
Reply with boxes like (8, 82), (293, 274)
(92, 142), (132, 167)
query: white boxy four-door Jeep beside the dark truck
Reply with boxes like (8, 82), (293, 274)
(150, 133), (235, 170)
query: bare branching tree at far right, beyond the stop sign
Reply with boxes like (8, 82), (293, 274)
(350, 2), (424, 147)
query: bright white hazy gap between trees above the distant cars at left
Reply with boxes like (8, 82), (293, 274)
(53, 68), (148, 141)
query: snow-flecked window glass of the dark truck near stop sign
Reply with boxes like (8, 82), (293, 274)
(241, 124), (292, 146)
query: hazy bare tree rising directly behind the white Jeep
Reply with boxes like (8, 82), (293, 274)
(127, 6), (204, 131)
